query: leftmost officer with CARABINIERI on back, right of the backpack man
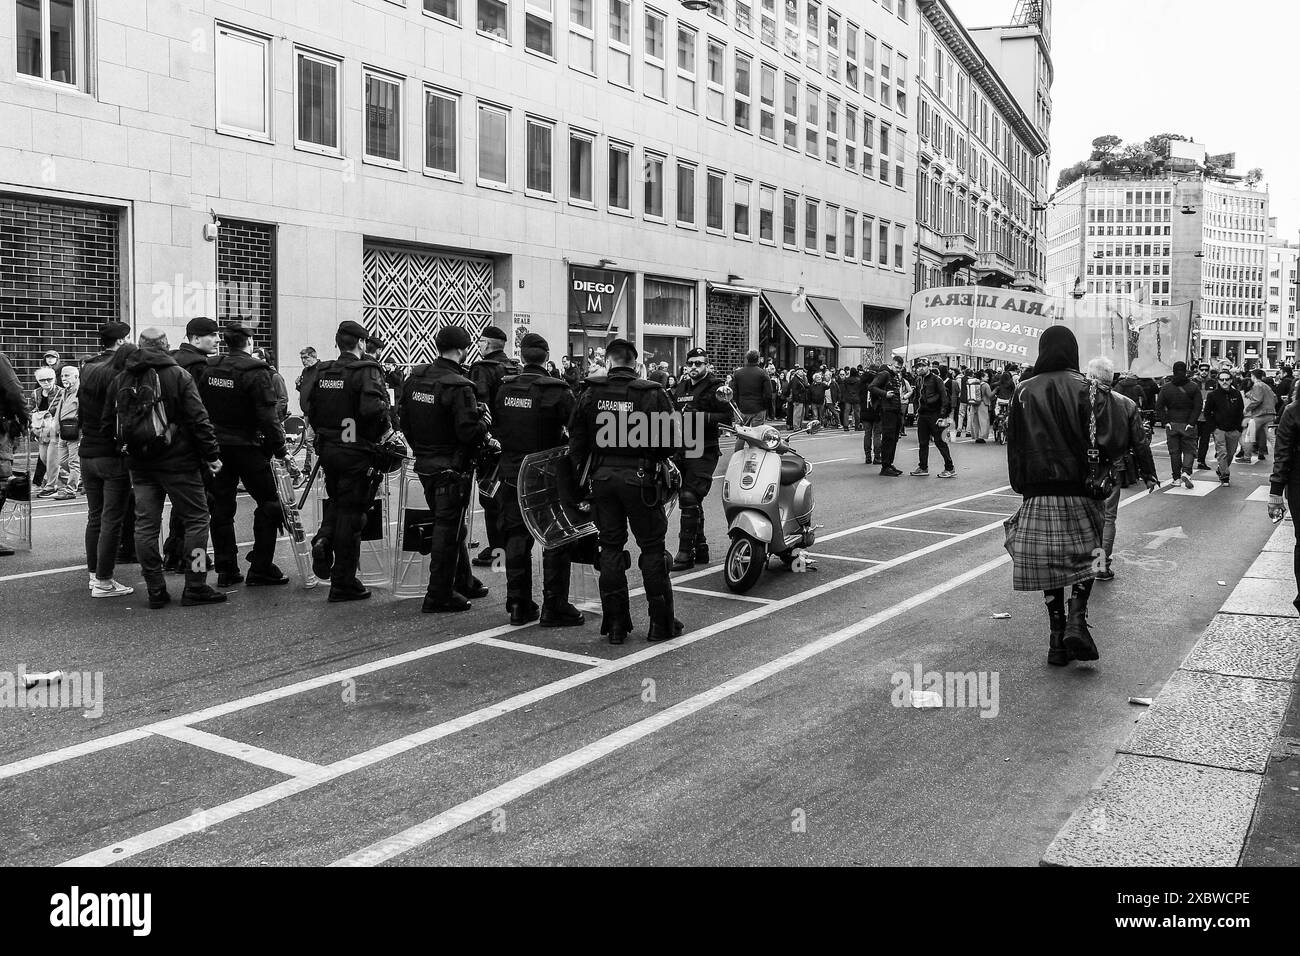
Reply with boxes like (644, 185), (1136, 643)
(196, 323), (289, 588)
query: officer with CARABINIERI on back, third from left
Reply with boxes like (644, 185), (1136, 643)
(398, 325), (491, 614)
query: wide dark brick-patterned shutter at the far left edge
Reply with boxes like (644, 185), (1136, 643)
(0, 195), (122, 389)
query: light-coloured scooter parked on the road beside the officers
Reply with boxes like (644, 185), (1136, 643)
(716, 385), (822, 594)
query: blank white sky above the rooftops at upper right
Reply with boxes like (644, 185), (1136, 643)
(948, 0), (1300, 242)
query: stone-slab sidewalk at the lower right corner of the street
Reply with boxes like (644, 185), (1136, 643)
(1041, 522), (1300, 866)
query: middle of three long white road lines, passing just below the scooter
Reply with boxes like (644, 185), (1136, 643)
(61, 489), (1019, 866)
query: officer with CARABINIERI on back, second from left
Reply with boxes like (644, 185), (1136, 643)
(302, 321), (389, 602)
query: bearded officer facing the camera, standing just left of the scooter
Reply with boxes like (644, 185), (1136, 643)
(672, 349), (735, 571)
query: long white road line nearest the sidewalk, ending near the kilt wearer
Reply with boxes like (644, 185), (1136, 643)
(332, 554), (1011, 866)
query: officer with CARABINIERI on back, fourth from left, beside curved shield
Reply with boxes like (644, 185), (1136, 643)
(493, 332), (584, 627)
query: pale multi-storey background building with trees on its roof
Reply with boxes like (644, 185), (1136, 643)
(1048, 167), (1277, 364)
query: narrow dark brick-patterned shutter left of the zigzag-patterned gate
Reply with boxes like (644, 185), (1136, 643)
(217, 219), (280, 364)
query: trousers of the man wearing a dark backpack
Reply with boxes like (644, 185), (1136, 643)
(131, 466), (209, 591)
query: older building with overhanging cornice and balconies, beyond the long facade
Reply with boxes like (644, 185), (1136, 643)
(915, 0), (1052, 295)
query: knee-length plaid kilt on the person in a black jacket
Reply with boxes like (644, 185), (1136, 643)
(1004, 496), (1106, 591)
